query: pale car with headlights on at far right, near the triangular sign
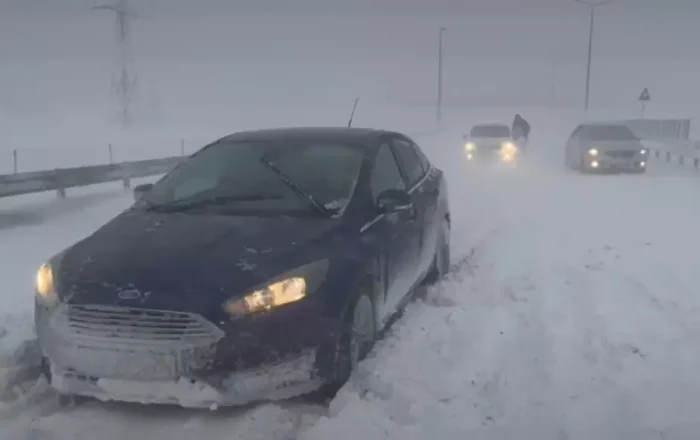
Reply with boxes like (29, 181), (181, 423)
(565, 123), (649, 173)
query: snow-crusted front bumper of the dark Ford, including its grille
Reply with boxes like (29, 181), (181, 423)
(36, 303), (338, 407)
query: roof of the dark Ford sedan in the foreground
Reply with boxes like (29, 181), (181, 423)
(220, 127), (399, 143)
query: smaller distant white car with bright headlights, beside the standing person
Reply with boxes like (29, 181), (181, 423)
(463, 124), (520, 164)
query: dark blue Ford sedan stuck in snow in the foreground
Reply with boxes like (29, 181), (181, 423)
(35, 128), (450, 407)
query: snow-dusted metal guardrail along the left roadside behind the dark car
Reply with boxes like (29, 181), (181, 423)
(0, 156), (186, 197)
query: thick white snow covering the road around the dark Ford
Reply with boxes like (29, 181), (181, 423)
(0, 129), (700, 440)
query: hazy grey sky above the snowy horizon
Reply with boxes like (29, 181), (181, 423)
(0, 0), (700, 138)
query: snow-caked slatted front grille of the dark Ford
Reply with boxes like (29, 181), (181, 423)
(51, 305), (223, 348)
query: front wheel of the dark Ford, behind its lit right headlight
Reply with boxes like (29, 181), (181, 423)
(320, 292), (377, 397)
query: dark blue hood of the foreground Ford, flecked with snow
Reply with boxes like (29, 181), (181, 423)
(56, 211), (340, 313)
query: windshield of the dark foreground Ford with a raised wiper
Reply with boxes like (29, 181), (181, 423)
(135, 141), (364, 214)
